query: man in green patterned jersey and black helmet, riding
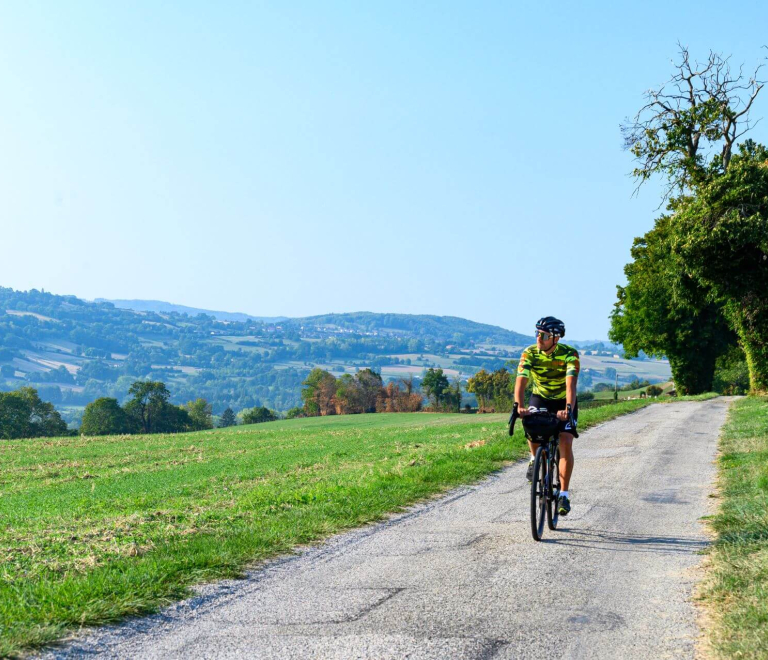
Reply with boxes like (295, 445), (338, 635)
(515, 316), (579, 516)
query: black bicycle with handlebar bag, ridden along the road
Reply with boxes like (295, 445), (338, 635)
(508, 403), (576, 541)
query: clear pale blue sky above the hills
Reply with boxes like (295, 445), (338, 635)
(0, 0), (768, 339)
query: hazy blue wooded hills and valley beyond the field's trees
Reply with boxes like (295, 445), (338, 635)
(0, 287), (653, 423)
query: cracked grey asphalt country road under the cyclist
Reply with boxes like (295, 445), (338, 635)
(44, 398), (729, 660)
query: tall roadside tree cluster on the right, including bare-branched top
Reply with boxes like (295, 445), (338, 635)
(609, 48), (768, 394)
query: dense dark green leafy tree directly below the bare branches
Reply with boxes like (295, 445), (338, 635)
(608, 216), (735, 394)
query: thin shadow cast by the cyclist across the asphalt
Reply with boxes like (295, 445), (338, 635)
(544, 527), (707, 555)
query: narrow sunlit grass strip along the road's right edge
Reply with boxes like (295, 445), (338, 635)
(701, 397), (768, 658)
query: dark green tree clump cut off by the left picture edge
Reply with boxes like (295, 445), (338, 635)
(0, 387), (68, 440)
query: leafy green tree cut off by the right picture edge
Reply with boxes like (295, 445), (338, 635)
(673, 142), (768, 392)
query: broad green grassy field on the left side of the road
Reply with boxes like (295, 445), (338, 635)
(0, 400), (650, 656)
